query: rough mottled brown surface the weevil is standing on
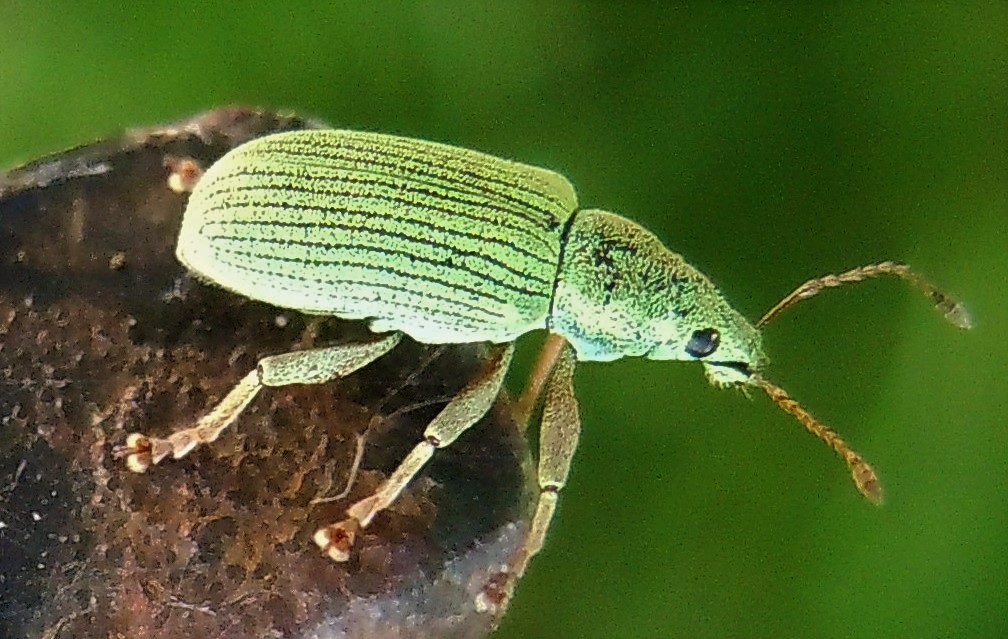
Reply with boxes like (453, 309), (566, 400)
(0, 109), (530, 638)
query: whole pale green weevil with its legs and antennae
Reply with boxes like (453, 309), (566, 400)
(119, 130), (970, 610)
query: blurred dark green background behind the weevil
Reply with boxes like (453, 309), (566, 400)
(0, 0), (1008, 638)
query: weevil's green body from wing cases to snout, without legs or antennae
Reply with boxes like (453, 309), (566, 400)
(177, 131), (763, 378)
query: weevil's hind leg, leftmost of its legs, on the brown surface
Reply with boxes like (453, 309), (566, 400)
(115, 333), (402, 473)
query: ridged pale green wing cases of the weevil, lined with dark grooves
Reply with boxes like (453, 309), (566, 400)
(177, 131), (576, 343)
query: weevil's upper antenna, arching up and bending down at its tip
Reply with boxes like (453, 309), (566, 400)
(756, 261), (973, 329)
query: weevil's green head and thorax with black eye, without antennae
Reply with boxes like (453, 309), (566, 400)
(550, 211), (766, 386)
